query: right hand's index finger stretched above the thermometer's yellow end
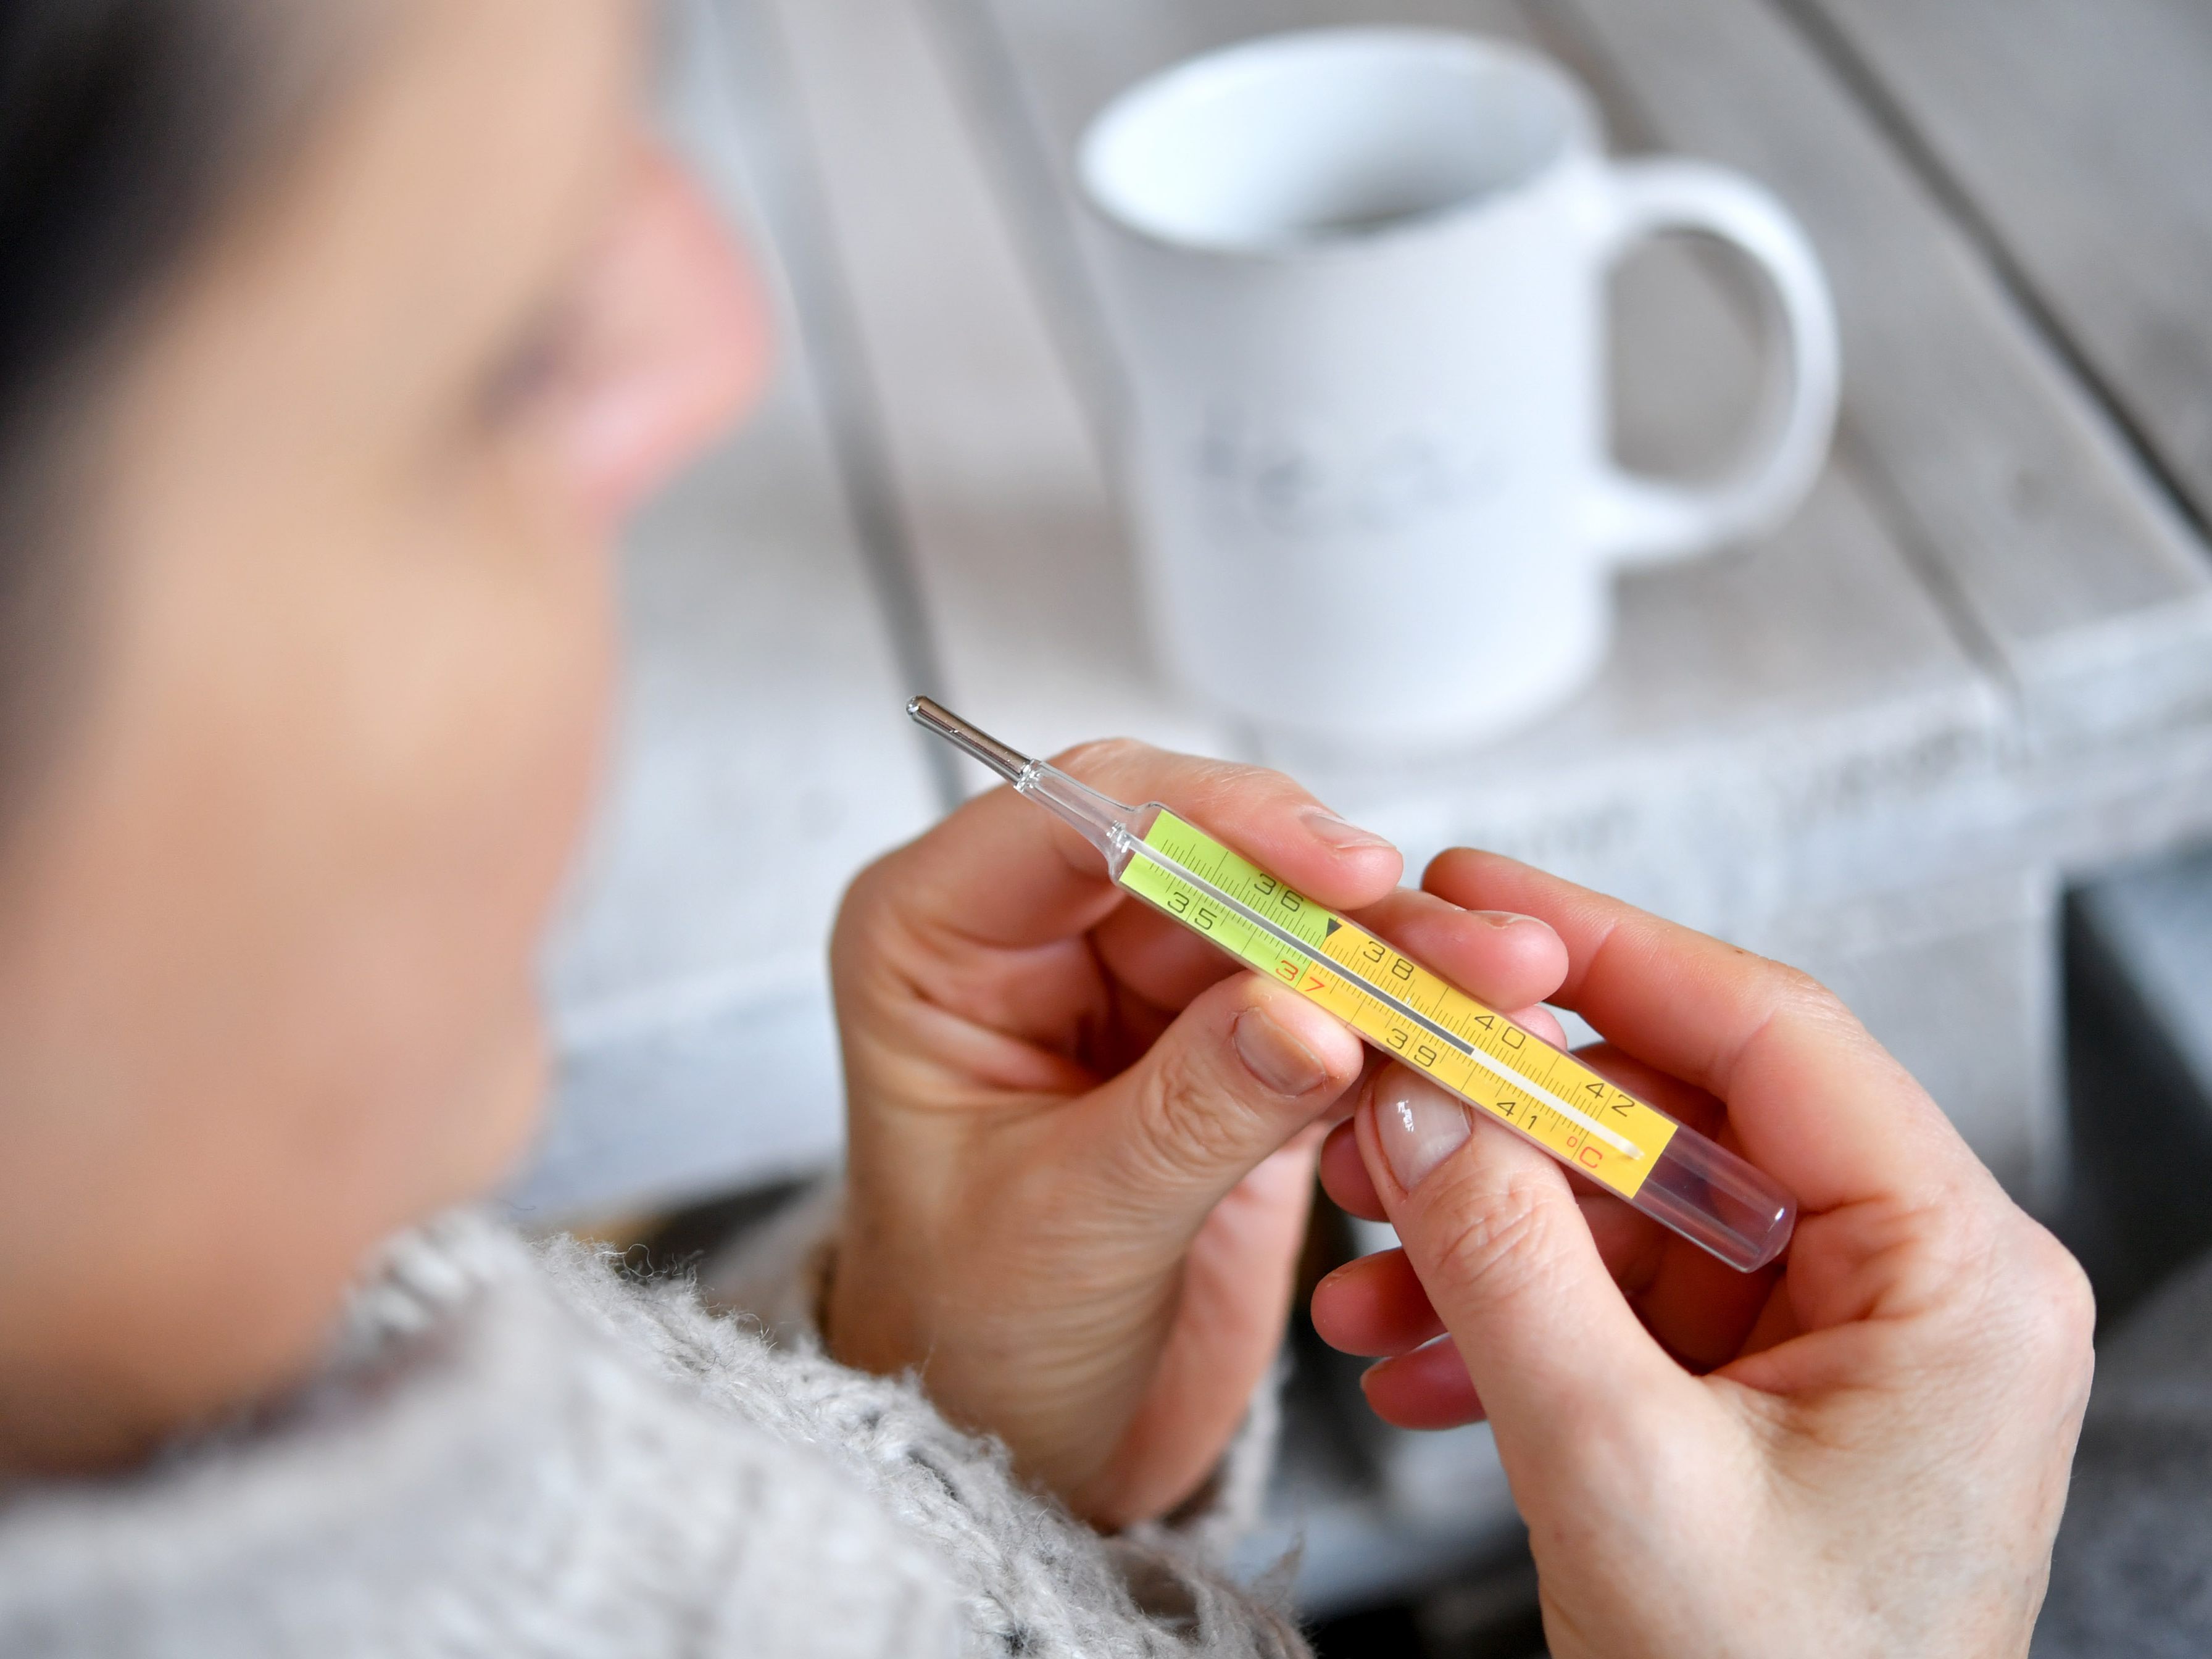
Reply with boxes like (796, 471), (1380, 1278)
(1423, 849), (1993, 1212)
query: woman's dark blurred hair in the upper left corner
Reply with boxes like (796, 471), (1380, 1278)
(0, 0), (298, 765)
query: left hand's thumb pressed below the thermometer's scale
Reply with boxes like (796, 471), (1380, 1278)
(1088, 973), (1363, 1228)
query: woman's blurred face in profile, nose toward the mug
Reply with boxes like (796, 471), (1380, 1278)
(0, 0), (761, 1469)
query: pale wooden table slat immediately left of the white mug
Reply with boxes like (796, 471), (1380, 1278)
(768, 0), (1236, 765)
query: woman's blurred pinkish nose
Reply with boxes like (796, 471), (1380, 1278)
(568, 139), (770, 522)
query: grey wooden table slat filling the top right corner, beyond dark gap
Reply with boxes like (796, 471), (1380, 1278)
(1798, 0), (2212, 539)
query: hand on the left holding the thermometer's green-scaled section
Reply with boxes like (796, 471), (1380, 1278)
(825, 743), (1566, 1526)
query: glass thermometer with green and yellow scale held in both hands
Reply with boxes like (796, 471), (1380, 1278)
(907, 697), (1796, 1272)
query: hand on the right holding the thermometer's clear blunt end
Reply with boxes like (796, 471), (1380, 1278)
(1314, 852), (2092, 1659)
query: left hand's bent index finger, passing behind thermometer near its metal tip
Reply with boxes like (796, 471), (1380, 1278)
(870, 739), (1405, 947)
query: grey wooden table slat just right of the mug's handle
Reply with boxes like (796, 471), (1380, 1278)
(1557, 0), (2212, 739)
